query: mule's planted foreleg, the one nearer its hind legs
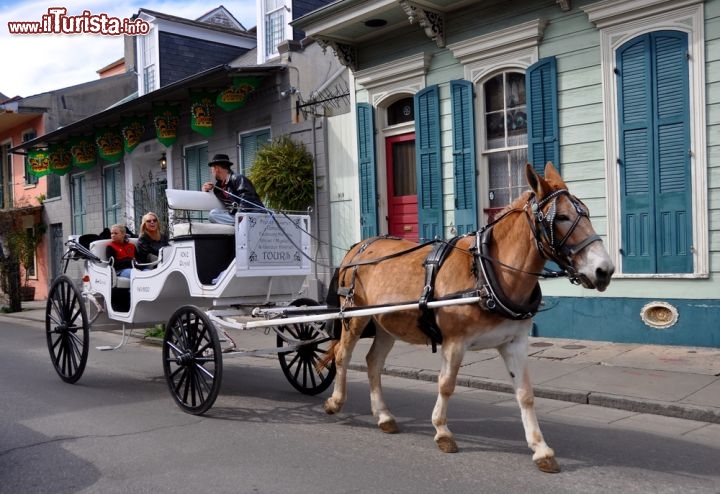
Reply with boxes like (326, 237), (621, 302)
(432, 341), (465, 453)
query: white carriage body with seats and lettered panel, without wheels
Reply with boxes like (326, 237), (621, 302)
(85, 189), (311, 323)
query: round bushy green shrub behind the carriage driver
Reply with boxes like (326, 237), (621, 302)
(248, 136), (315, 211)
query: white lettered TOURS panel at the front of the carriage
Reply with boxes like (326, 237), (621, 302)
(235, 213), (311, 276)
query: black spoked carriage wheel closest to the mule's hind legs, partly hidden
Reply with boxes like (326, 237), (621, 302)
(277, 298), (336, 395)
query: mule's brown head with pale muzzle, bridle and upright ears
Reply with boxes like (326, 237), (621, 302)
(526, 162), (615, 292)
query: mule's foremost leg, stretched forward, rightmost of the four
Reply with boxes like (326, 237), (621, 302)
(498, 334), (560, 473)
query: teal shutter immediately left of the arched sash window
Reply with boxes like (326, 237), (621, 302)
(450, 80), (478, 235)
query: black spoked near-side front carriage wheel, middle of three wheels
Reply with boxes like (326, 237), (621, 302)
(163, 305), (222, 415)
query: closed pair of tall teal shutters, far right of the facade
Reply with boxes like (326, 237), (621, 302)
(617, 31), (693, 273)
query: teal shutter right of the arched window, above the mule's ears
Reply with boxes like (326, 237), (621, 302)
(525, 57), (560, 175)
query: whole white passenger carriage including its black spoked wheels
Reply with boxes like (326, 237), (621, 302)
(46, 189), (335, 414)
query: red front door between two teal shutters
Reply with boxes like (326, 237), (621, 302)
(385, 133), (419, 242)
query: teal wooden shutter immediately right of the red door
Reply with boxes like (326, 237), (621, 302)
(415, 86), (443, 242)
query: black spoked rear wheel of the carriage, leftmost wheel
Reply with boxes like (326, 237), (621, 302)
(45, 274), (90, 384)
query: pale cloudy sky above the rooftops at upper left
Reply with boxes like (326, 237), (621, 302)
(0, 0), (257, 97)
